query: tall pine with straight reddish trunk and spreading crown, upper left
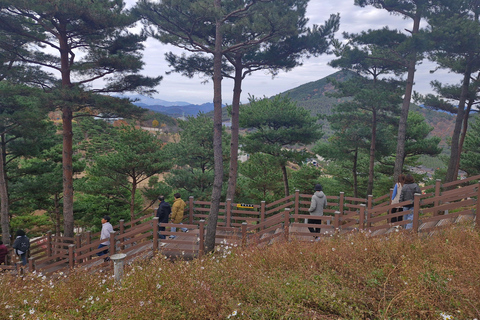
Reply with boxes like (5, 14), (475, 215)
(0, 0), (160, 237)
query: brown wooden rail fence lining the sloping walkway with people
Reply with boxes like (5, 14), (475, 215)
(0, 175), (480, 272)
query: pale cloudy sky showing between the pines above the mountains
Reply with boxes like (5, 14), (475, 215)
(126, 0), (459, 104)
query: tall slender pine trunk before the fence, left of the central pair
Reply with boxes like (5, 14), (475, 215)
(205, 0), (223, 253)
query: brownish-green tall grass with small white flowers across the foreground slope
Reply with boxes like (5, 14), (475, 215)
(0, 226), (480, 319)
